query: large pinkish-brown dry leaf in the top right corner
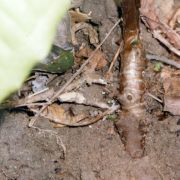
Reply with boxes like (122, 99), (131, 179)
(140, 0), (180, 53)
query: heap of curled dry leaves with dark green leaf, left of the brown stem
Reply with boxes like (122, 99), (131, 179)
(4, 9), (119, 127)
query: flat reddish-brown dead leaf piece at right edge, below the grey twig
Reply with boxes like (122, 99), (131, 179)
(161, 68), (180, 115)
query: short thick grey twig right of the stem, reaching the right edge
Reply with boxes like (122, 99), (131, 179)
(146, 54), (180, 69)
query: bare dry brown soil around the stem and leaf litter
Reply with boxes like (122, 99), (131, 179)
(0, 0), (180, 180)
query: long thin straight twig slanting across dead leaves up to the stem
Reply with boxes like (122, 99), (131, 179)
(29, 19), (122, 127)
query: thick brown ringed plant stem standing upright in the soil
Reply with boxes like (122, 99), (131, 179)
(116, 0), (145, 158)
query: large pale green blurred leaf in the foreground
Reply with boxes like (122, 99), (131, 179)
(0, 0), (70, 102)
